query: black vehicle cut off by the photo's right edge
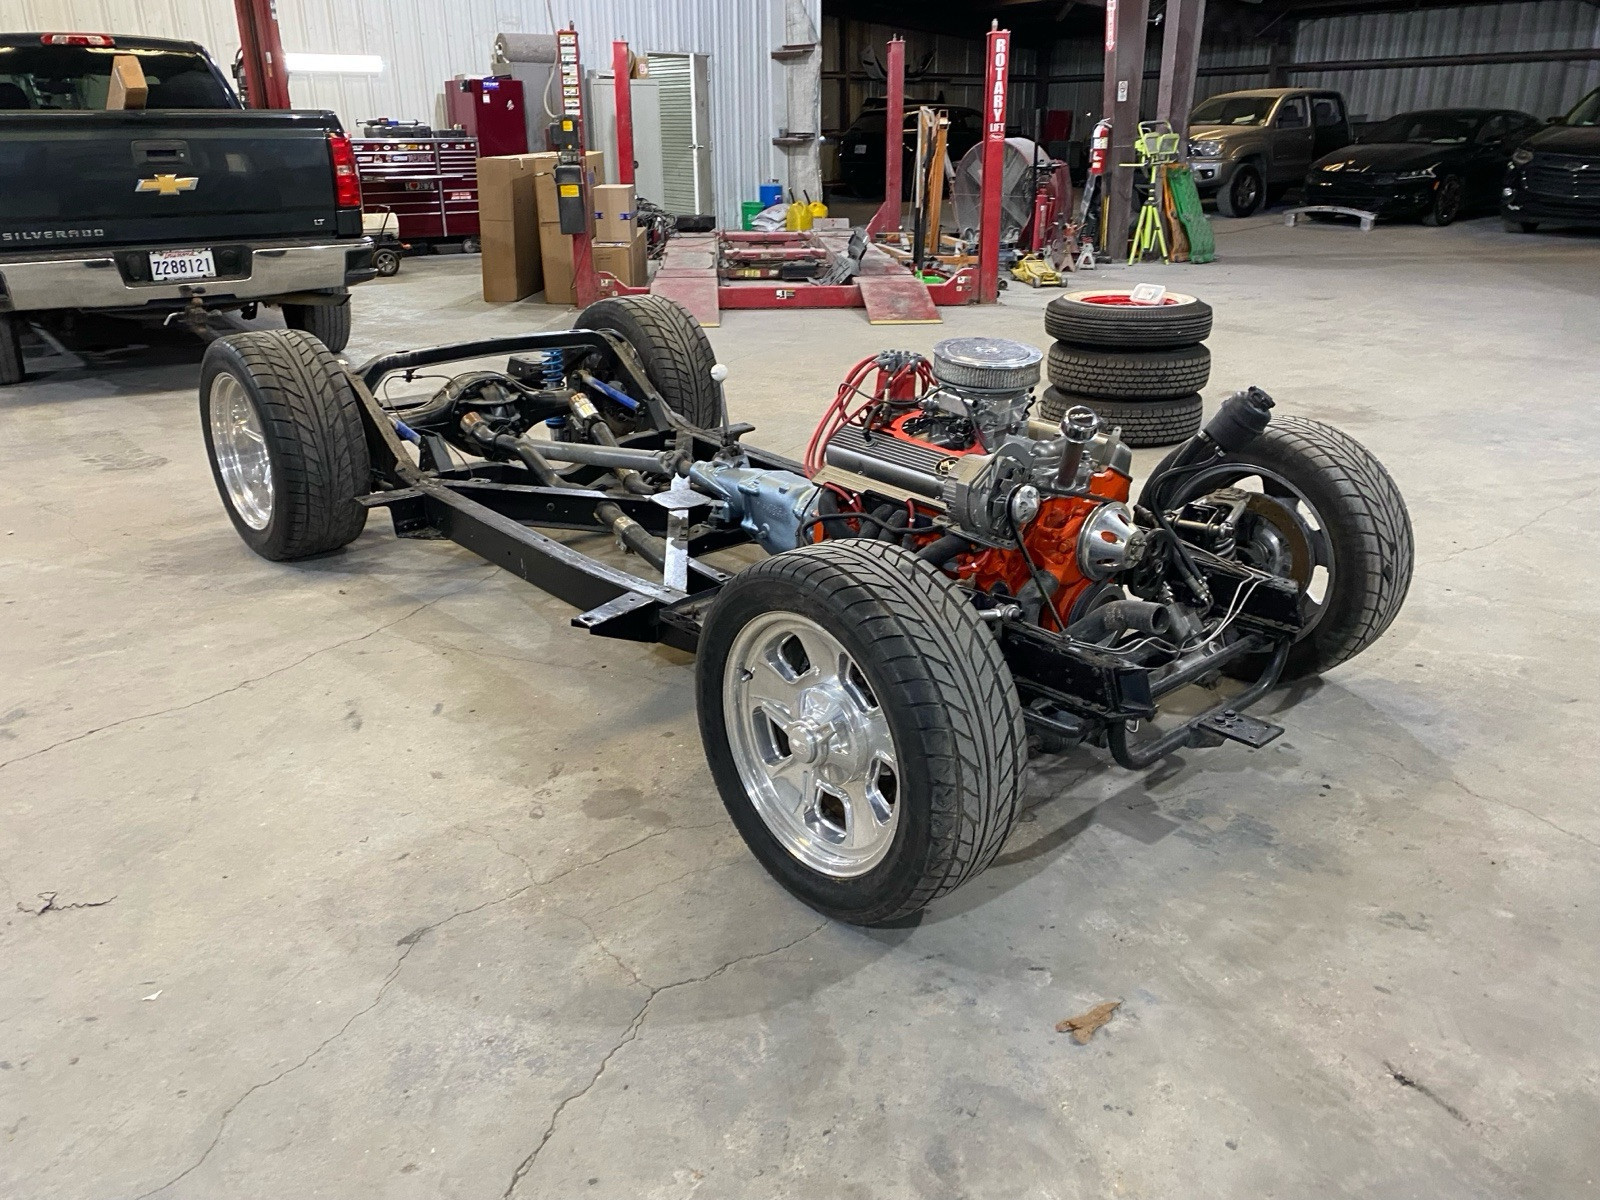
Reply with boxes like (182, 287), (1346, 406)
(1501, 88), (1600, 234)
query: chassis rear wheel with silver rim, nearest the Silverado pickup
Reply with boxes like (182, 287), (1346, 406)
(200, 330), (371, 562)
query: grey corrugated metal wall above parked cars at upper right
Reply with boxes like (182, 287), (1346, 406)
(1290, 0), (1600, 118)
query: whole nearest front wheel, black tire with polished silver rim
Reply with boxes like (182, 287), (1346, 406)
(696, 539), (1027, 925)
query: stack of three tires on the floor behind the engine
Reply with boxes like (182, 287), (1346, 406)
(1040, 288), (1211, 446)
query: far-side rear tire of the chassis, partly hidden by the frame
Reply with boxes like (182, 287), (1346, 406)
(574, 296), (725, 429)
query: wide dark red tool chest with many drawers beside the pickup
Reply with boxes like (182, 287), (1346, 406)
(352, 136), (478, 242)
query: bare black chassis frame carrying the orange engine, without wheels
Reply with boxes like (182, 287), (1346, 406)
(352, 330), (1301, 770)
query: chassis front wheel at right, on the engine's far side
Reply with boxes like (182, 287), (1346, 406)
(1139, 416), (1416, 680)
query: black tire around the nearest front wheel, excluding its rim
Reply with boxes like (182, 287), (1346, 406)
(696, 539), (1027, 925)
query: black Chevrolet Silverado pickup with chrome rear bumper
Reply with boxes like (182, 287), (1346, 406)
(0, 34), (374, 384)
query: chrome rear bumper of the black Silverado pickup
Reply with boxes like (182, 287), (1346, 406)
(0, 238), (374, 312)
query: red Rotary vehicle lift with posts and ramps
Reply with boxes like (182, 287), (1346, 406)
(574, 27), (1011, 325)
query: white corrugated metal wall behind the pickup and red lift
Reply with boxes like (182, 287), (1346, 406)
(18, 0), (822, 224)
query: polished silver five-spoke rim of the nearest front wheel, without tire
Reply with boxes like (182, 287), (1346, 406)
(722, 611), (899, 878)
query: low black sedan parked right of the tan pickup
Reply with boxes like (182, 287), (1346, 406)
(1306, 109), (1539, 226)
